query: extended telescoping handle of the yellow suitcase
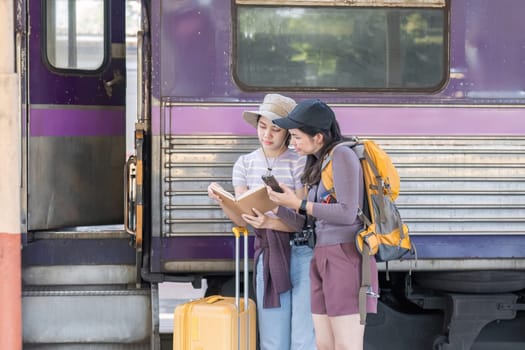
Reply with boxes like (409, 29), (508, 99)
(232, 226), (250, 349)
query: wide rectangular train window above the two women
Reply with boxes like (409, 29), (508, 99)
(234, 0), (447, 91)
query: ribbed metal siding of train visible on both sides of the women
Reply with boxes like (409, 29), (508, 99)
(161, 136), (525, 235)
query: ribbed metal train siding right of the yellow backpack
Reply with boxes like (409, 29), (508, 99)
(377, 137), (525, 235)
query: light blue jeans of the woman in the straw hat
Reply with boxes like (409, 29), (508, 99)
(256, 246), (316, 350)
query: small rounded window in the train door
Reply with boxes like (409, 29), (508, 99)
(45, 0), (106, 71)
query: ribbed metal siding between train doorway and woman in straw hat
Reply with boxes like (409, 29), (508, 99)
(162, 136), (258, 236)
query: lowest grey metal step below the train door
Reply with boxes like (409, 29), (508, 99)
(22, 285), (152, 350)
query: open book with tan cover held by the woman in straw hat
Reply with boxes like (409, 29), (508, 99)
(211, 186), (277, 215)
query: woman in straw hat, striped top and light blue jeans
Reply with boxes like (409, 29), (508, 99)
(208, 94), (315, 350)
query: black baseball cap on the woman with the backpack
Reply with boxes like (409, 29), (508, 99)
(273, 99), (335, 130)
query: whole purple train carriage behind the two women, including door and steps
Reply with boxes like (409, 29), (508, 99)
(16, 0), (525, 350)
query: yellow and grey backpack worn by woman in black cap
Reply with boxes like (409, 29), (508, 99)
(321, 139), (415, 324)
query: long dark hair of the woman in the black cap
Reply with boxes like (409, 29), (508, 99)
(299, 120), (345, 186)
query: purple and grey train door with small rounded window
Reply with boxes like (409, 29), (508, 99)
(24, 0), (126, 231)
